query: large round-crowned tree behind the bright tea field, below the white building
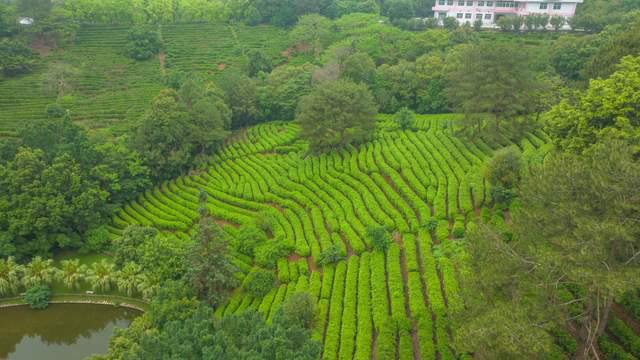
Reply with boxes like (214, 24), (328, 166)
(445, 44), (538, 134)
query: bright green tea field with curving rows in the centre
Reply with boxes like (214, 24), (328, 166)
(111, 116), (549, 359)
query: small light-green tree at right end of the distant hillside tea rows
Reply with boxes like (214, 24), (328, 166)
(290, 14), (334, 57)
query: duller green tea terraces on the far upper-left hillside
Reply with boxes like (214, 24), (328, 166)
(0, 24), (288, 137)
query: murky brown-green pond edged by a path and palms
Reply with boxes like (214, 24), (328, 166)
(0, 304), (141, 360)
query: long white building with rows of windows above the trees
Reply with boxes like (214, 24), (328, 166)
(433, 0), (583, 27)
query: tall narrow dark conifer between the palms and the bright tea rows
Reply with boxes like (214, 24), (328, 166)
(187, 217), (237, 306)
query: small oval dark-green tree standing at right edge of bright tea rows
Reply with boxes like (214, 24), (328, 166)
(486, 147), (522, 203)
